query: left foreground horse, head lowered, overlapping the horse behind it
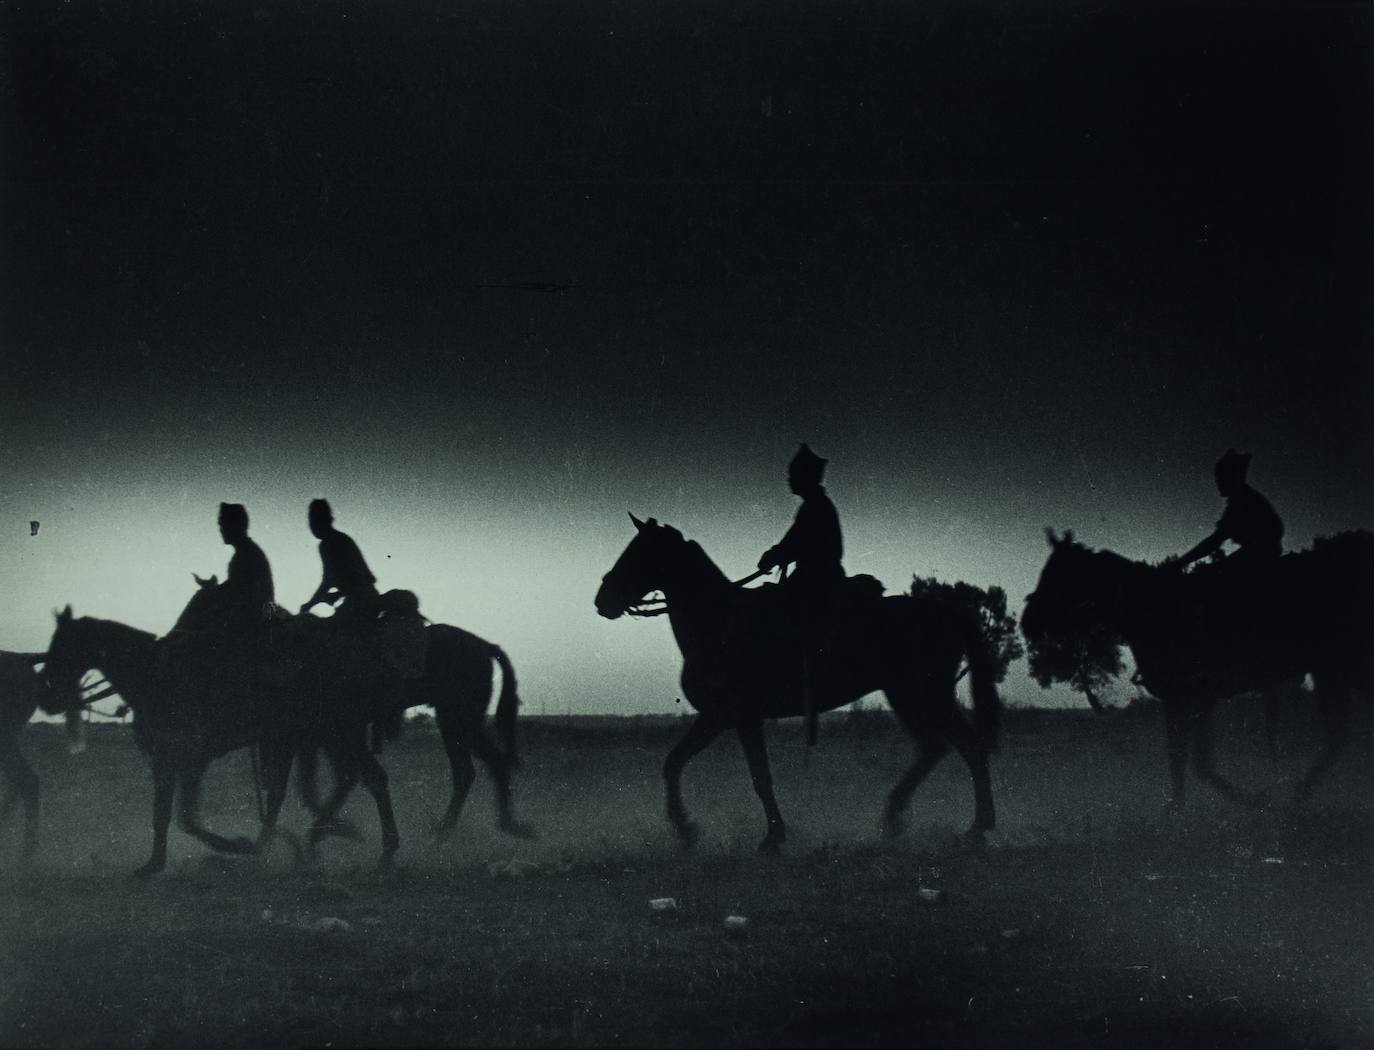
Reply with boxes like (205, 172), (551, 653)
(41, 606), (400, 877)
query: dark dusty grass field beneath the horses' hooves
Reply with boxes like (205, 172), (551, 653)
(0, 701), (1374, 1047)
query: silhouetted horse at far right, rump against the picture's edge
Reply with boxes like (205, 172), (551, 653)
(1021, 529), (1374, 811)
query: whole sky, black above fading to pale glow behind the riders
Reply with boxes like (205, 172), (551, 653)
(0, 0), (1374, 712)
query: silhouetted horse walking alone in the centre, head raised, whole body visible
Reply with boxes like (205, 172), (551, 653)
(595, 514), (1002, 852)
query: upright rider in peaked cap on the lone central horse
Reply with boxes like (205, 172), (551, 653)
(758, 444), (845, 742)
